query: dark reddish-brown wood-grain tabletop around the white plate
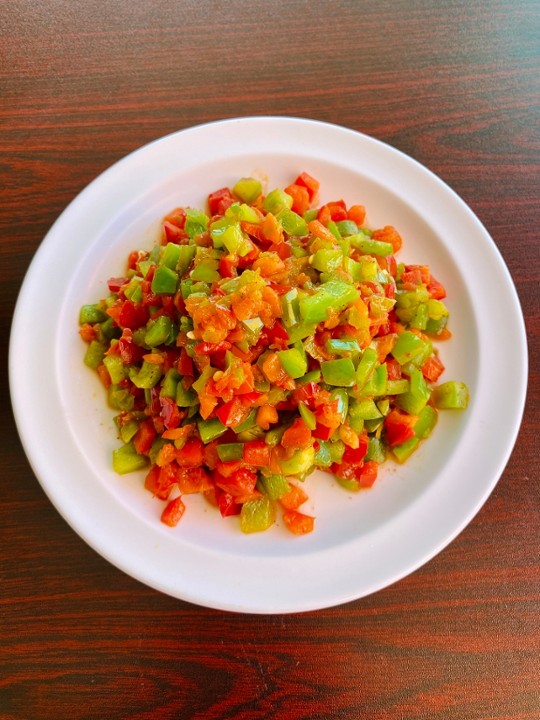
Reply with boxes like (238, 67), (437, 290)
(0, 0), (540, 720)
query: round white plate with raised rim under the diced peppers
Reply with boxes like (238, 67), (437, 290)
(10, 117), (527, 613)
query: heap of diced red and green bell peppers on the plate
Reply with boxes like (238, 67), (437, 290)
(79, 172), (469, 535)
